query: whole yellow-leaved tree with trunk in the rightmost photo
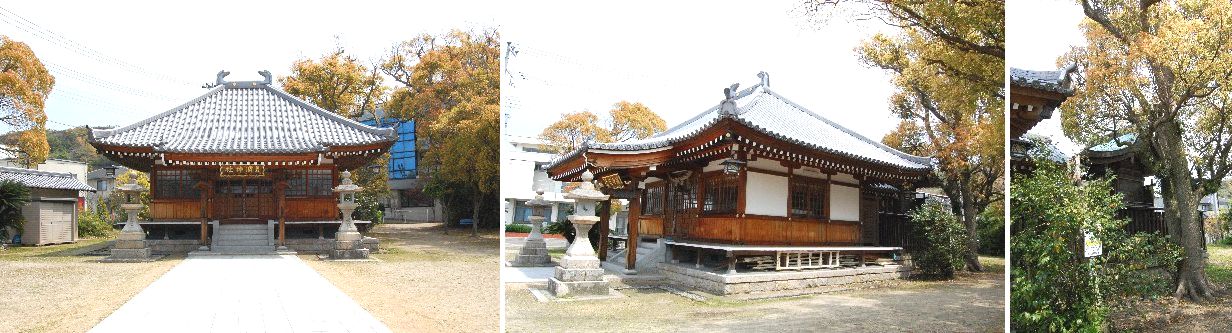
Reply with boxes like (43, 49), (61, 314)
(1061, 0), (1232, 301)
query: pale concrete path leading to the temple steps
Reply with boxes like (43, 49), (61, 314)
(90, 255), (395, 333)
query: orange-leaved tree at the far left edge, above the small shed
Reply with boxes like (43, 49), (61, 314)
(0, 36), (55, 168)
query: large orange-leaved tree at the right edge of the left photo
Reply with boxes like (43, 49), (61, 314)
(381, 30), (500, 234)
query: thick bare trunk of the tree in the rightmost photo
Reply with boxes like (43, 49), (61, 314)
(1156, 123), (1222, 302)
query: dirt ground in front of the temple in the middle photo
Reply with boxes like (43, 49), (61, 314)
(505, 258), (1005, 332)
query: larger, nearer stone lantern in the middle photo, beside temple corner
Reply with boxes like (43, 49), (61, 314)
(547, 170), (609, 297)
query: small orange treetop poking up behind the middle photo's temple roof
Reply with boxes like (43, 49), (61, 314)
(540, 101), (668, 153)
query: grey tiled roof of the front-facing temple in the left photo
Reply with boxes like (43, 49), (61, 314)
(91, 81), (397, 154)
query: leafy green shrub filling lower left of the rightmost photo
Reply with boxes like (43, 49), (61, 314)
(1010, 159), (1180, 332)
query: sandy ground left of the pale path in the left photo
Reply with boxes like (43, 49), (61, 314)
(0, 239), (182, 332)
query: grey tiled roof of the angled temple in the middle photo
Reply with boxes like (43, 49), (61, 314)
(553, 77), (931, 170)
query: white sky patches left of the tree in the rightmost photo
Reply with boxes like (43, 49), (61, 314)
(1005, 0), (1085, 155)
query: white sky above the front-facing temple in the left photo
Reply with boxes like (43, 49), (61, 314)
(0, 0), (500, 130)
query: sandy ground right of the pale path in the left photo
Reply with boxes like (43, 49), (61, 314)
(303, 223), (500, 332)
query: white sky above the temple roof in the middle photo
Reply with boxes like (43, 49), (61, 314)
(501, 0), (897, 139)
